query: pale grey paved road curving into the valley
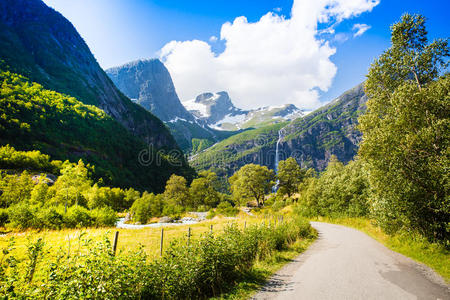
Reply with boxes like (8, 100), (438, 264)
(253, 222), (450, 300)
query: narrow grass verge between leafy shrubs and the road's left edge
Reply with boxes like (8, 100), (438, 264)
(213, 236), (317, 300)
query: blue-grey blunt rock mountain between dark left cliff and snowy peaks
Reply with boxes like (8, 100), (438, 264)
(106, 59), (218, 151)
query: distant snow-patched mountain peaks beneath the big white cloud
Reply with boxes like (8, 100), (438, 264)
(183, 92), (304, 130)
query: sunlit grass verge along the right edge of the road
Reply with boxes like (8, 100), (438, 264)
(317, 217), (450, 282)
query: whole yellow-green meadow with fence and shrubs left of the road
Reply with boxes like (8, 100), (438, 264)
(0, 214), (316, 299)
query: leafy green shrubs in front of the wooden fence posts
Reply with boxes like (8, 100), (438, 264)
(0, 219), (313, 299)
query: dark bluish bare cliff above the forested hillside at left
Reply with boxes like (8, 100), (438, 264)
(0, 0), (177, 148)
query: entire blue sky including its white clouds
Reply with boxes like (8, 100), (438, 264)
(44, 0), (450, 110)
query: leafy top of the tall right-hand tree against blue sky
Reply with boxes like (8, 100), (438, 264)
(365, 14), (450, 99)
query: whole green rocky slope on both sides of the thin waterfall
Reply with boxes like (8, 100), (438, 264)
(191, 84), (367, 176)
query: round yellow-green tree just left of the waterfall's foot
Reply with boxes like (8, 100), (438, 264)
(229, 164), (275, 206)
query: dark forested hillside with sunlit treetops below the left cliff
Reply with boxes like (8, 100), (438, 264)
(0, 71), (193, 192)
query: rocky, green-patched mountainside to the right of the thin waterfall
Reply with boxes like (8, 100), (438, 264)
(279, 83), (367, 171)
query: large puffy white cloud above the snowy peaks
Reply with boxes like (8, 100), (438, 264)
(160, 0), (379, 109)
